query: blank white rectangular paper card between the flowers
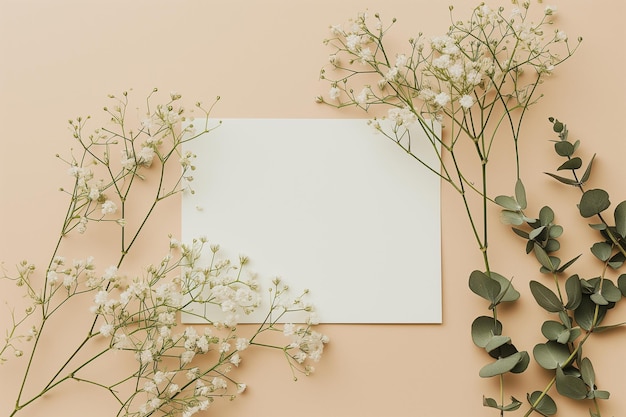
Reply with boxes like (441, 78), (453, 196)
(182, 119), (442, 323)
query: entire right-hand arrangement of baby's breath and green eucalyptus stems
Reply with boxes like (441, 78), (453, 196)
(317, 1), (626, 416)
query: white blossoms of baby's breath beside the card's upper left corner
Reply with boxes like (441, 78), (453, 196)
(64, 90), (195, 233)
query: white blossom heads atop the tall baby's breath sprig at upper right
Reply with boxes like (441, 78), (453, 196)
(317, 2), (571, 130)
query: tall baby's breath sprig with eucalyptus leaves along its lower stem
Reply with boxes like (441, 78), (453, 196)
(317, 1), (582, 415)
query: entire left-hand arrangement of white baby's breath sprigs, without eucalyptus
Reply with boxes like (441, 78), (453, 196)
(0, 89), (328, 417)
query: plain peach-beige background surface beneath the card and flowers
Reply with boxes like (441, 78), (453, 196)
(0, 0), (626, 417)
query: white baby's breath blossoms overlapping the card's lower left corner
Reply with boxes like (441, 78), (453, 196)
(83, 238), (328, 416)
